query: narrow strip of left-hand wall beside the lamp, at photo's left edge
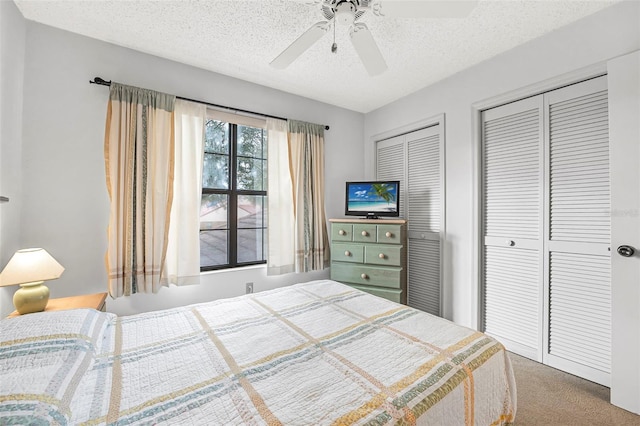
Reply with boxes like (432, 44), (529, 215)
(0, 1), (26, 318)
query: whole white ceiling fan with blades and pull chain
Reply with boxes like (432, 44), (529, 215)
(271, 0), (477, 76)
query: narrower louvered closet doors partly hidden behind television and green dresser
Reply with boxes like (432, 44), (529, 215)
(376, 125), (444, 316)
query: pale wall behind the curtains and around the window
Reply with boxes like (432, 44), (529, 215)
(0, 22), (364, 315)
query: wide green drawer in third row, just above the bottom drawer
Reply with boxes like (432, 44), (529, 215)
(331, 262), (402, 289)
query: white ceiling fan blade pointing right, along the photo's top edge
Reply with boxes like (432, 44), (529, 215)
(372, 0), (478, 18)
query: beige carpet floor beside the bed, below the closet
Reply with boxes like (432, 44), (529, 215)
(509, 353), (640, 426)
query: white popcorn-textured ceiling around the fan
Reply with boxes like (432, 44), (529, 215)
(15, 0), (617, 113)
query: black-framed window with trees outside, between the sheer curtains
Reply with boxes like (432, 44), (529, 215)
(200, 112), (267, 271)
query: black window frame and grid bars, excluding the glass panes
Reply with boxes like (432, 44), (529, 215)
(200, 118), (268, 272)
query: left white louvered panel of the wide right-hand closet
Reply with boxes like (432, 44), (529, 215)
(482, 96), (544, 361)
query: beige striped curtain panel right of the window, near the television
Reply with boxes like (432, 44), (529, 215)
(289, 120), (329, 272)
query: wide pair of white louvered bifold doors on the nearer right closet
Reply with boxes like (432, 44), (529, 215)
(482, 77), (611, 386)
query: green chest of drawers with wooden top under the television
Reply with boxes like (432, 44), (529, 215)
(329, 219), (407, 304)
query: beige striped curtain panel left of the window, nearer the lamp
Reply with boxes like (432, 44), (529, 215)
(104, 83), (175, 298)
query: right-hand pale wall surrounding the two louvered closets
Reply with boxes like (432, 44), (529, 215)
(364, 2), (640, 327)
